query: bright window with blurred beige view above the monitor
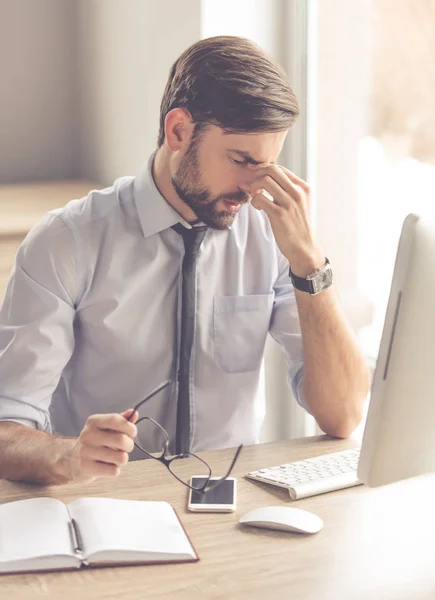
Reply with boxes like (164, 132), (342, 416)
(358, 0), (435, 358)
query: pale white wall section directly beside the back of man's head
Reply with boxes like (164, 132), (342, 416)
(79, 0), (201, 184)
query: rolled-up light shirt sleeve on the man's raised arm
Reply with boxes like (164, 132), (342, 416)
(269, 250), (309, 412)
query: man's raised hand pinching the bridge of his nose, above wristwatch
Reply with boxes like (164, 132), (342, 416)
(240, 163), (325, 277)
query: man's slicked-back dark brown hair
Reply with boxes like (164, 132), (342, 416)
(158, 36), (299, 147)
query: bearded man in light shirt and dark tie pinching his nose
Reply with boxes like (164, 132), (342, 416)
(0, 37), (368, 484)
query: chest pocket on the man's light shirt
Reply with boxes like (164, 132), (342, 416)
(213, 292), (274, 373)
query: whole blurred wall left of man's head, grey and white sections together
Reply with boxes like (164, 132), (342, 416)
(0, 0), (201, 183)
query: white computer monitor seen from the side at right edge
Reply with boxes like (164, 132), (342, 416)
(358, 214), (435, 486)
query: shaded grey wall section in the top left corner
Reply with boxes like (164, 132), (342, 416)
(0, 0), (78, 184)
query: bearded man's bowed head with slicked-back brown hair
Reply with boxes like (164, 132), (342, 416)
(158, 36), (298, 229)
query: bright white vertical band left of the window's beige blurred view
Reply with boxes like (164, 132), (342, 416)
(308, 0), (372, 331)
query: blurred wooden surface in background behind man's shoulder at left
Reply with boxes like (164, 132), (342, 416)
(0, 180), (101, 298)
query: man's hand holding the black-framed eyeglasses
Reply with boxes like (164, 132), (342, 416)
(69, 409), (138, 483)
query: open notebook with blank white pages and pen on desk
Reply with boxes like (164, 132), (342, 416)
(0, 498), (199, 573)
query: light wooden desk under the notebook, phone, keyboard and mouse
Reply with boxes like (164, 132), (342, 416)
(0, 436), (435, 600)
